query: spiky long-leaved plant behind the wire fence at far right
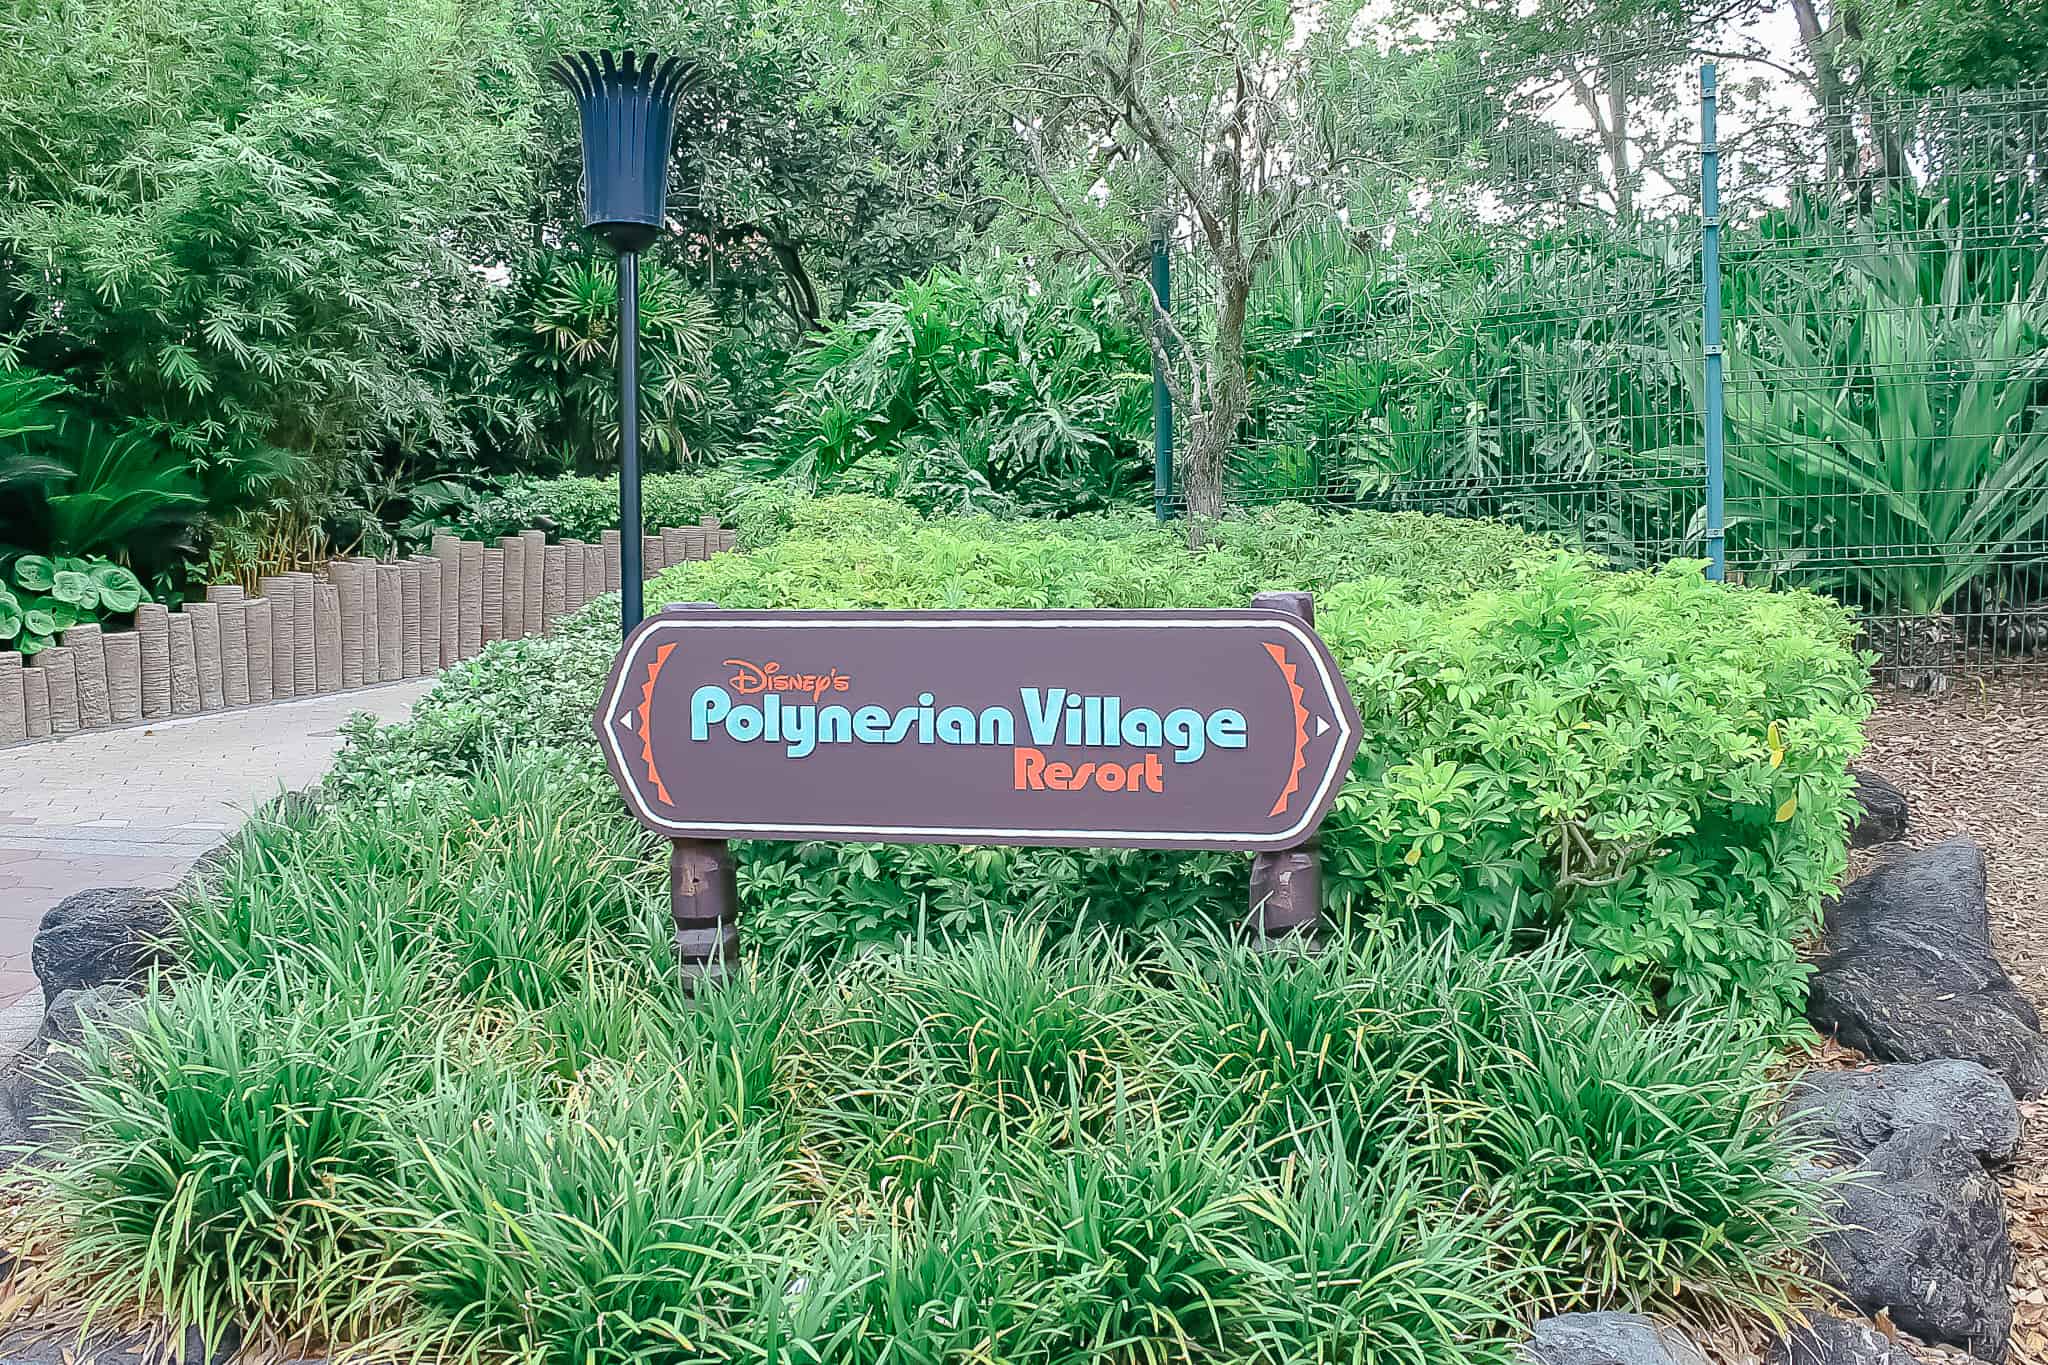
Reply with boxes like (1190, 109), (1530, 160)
(1703, 189), (2048, 616)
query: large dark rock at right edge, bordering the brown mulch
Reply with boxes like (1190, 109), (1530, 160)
(1806, 837), (2048, 1099)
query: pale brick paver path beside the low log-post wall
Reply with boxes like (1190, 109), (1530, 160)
(0, 679), (432, 1007)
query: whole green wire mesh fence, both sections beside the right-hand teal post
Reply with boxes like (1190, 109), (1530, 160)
(1176, 51), (2048, 681)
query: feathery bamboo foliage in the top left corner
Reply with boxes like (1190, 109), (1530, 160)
(0, 0), (528, 577)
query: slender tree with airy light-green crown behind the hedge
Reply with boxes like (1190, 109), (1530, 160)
(790, 0), (1368, 518)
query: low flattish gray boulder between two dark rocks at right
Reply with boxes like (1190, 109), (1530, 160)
(1784, 1058), (2019, 1162)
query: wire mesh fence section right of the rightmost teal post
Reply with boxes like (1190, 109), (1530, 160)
(1722, 90), (2048, 681)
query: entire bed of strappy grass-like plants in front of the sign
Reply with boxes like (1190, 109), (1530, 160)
(16, 751), (1815, 1365)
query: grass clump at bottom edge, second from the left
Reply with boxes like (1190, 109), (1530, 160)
(372, 1060), (782, 1365)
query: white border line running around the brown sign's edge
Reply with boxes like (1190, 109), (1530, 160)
(596, 608), (1352, 847)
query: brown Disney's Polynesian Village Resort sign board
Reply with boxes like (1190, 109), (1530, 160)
(592, 608), (1360, 851)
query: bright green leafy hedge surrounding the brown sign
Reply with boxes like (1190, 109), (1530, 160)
(334, 499), (1870, 1019)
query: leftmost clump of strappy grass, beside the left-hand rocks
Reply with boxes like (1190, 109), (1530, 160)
(28, 960), (422, 1342)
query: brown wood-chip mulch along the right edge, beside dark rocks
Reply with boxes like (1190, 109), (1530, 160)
(1851, 669), (2048, 1365)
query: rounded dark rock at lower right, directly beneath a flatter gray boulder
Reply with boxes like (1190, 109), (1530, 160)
(1819, 1126), (2013, 1361)
